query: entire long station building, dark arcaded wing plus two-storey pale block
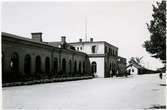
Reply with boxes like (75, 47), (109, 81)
(2, 32), (126, 83)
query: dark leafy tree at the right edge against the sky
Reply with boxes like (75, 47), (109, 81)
(143, 1), (166, 64)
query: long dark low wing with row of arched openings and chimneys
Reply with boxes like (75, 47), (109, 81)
(2, 32), (92, 83)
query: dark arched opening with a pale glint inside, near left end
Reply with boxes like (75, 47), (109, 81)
(10, 53), (19, 74)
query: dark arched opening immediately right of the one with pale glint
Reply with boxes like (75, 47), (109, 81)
(24, 55), (31, 75)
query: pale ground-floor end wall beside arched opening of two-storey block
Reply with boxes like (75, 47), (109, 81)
(90, 57), (104, 78)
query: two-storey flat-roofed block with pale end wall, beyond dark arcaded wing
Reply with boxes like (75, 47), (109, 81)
(70, 38), (126, 77)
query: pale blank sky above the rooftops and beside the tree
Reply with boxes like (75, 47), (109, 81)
(1, 0), (163, 69)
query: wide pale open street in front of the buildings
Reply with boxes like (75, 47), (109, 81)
(2, 74), (166, 110)
